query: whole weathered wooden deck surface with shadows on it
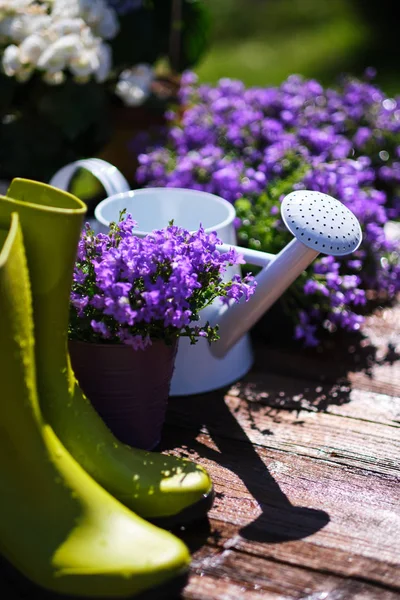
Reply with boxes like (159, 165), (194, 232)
(163, 307), (400, 600)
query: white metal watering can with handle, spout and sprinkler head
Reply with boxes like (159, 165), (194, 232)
(50, 159), (362, 396)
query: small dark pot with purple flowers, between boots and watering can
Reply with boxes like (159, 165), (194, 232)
(69, 213), (255, 449)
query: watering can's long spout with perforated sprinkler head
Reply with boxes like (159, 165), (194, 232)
(211, 190), (362, 358)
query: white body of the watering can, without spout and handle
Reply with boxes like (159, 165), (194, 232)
(91, 188), (269, 396)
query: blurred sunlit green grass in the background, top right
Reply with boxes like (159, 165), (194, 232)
(196, 0), (400, 94)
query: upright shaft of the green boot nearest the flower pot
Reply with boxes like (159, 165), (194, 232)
(0, 179), (86, 393)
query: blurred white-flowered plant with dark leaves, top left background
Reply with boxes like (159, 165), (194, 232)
(0, 0), (209, 180)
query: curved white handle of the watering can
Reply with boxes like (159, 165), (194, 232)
(49, 158), (131, 196)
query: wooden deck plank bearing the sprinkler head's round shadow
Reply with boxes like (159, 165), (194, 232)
(160, 426), (400, 589)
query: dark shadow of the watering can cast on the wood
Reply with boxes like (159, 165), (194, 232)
(162, 392), (329, 543)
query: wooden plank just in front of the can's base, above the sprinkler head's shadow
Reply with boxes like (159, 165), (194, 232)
(167, 388), (400, 476)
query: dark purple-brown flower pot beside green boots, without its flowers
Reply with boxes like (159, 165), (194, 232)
(69, 340), (178, 450)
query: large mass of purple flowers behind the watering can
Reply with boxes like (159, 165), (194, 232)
(136, 70), (400, 345)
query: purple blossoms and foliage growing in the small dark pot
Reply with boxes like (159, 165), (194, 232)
(69, 215), (255, 349)
